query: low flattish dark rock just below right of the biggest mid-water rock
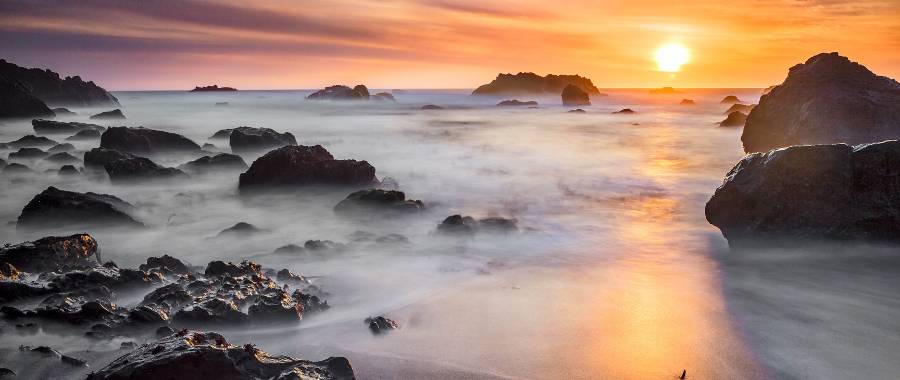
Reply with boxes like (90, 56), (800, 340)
(334, 189), (425, 216)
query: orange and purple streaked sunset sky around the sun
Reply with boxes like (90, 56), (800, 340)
(0, 0), (900, 90)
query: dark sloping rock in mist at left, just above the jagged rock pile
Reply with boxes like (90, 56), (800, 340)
(17, 186), (144, 229)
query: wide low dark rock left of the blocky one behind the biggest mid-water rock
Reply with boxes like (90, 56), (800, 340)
(100, 127), (200, 154)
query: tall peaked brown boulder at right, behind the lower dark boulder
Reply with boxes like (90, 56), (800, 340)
(741, 53), (900, 152)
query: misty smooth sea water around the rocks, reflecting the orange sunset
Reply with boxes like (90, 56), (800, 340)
(0, 89), (900, 379)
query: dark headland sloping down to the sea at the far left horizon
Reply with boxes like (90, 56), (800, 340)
(0, 59), (119, 107)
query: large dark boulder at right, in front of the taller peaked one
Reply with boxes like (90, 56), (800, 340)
(706, 140), (900, 243)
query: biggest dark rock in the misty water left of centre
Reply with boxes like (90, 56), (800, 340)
(238, 145), (377, 191)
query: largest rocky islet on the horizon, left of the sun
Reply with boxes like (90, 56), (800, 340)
(472, 72), (603, 96)
